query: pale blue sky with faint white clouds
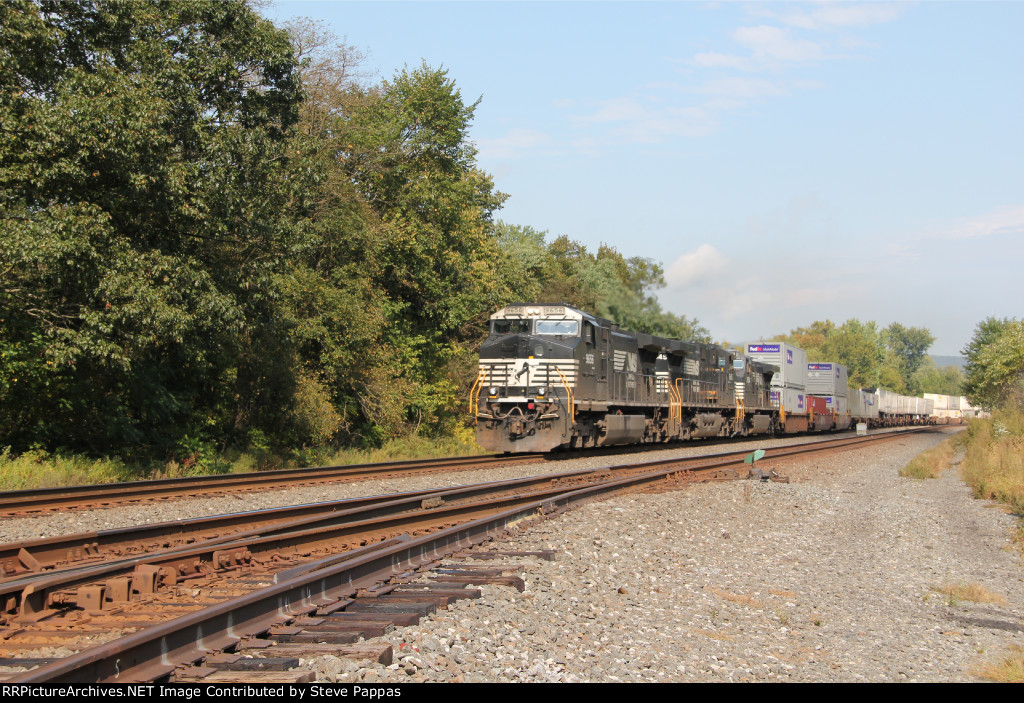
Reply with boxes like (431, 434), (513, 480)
(263, 0), (1024, 355)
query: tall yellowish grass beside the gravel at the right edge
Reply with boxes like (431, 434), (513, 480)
(961, 410), (1024, 516)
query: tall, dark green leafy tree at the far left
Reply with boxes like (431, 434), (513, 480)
(0, 0), (301, 451)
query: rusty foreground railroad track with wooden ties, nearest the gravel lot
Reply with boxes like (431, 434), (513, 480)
(0, 433), (942, 683)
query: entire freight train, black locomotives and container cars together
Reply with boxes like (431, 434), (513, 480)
(469, 304), (932, 452)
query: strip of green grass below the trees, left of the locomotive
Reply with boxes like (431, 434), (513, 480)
(0, 429), (483, 490)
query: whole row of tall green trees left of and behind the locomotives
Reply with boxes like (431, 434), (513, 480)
(0, 0), (708, 460)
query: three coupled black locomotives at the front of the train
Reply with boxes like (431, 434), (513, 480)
(470, 304), (784, 452)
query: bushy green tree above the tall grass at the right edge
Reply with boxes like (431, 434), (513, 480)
(961, 317), (1024, 411)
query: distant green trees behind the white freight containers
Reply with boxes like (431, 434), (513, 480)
(778, 319), (964, 395)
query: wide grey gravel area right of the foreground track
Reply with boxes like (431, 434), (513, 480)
(303, 435), (1024, 683)
